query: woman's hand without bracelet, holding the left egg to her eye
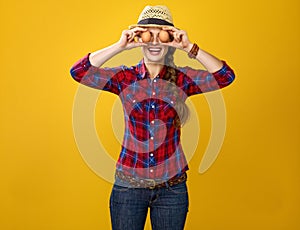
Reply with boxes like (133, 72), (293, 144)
(118, 27), (147, 49)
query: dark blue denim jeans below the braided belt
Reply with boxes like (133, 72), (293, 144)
(110, 181), (189, 230)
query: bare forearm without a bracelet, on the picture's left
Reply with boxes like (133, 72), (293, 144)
(89, 42), (124, 67)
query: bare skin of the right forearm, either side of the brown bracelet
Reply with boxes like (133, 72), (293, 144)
(184, 43), (223, 73)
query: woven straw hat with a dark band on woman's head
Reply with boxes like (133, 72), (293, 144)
(129, 5), (174, 29)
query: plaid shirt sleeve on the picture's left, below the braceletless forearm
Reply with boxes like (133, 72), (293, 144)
(70, 54), (124, 94)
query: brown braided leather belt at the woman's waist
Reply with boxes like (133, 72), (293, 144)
(115, 170), (187, 189)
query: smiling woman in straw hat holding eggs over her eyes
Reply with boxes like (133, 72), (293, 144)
(71, 6), (234, 230)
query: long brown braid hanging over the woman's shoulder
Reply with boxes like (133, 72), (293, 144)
(163, 47), (190, 127)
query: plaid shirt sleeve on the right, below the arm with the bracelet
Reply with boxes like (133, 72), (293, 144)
(180, 61), (235, 96)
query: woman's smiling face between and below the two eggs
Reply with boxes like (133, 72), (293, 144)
(142, 27), (168, 63)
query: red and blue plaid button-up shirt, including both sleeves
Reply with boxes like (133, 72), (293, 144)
(71, 54), (235, 180)
